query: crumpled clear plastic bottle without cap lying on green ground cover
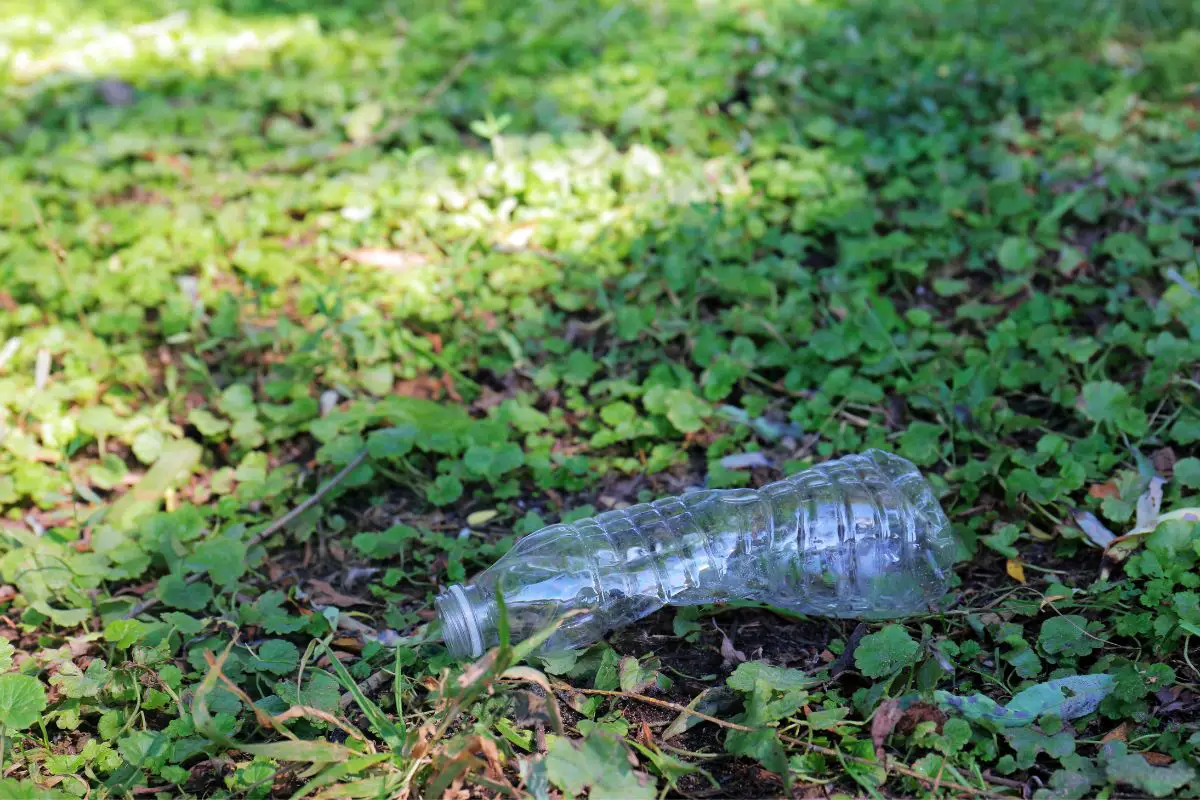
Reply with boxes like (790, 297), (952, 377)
(436, 450), (955, 657)
